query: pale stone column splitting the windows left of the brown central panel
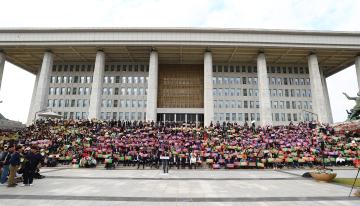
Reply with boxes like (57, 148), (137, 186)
(88, 51), (105, 119)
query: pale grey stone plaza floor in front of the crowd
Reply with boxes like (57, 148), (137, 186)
(0, 168), (360, 206)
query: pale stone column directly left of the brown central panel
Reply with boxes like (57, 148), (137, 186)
(146, 51), (158, 122)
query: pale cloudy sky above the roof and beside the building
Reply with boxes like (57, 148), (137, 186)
(0, 0), (360, 123)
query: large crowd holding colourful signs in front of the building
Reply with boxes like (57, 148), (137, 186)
(0, 117), (360, 186)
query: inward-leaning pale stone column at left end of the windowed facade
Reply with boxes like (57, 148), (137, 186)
(28, 51), (54, 119)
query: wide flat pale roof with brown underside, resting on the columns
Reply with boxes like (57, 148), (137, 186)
(0, 28), (360, 76)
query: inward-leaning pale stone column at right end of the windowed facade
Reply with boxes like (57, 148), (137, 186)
(308, 54), (329, 123)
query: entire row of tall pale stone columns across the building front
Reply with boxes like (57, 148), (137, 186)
(0, 50), (354, 126)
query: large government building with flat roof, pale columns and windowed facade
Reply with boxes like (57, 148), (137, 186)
(0, 28), (360, 126)
